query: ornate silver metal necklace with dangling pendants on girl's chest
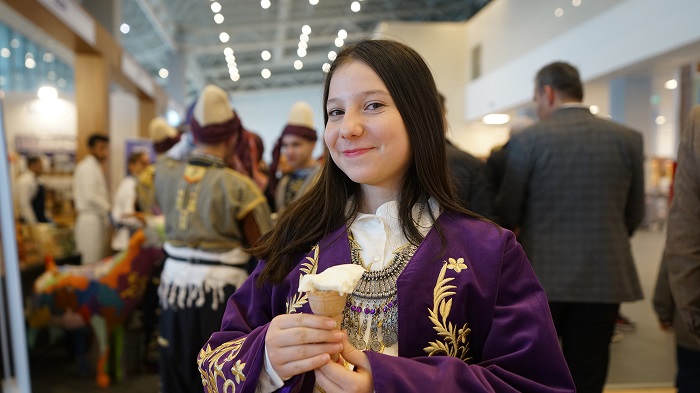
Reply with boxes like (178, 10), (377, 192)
(343, 234), (417, 352)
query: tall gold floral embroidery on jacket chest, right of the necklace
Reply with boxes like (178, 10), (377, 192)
(423, 258), (472, 363)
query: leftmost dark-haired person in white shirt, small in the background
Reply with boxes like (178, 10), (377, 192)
(17, 157), (50, 224)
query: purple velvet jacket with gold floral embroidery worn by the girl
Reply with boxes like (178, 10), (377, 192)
(198, 212), (575, 393)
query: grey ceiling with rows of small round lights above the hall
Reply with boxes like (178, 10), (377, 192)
(120, 0), (490, 96)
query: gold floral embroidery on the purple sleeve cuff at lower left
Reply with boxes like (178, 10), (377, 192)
(197, 337), (246, 393)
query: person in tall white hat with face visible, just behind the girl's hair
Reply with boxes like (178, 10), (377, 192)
(268, 101), (321, 212)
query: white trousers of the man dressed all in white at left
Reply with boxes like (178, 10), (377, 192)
(75, 212), (110, 265)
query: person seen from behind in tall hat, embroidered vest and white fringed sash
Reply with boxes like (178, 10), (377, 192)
(155, 85), (272, 393)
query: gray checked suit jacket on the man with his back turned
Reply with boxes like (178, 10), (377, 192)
(497, 107), (644, 303)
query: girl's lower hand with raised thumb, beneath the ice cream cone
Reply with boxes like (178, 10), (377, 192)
(314, 332), (374, 393)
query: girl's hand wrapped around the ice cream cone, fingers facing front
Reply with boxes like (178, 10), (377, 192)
(265, 314), (345, 380)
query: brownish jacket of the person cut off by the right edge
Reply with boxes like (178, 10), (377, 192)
(664, 105), (700, 336)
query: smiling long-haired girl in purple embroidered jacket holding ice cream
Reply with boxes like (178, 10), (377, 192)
(198, 40), (574, 393)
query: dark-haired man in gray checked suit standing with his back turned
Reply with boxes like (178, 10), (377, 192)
(497, 62), (644, 393)
